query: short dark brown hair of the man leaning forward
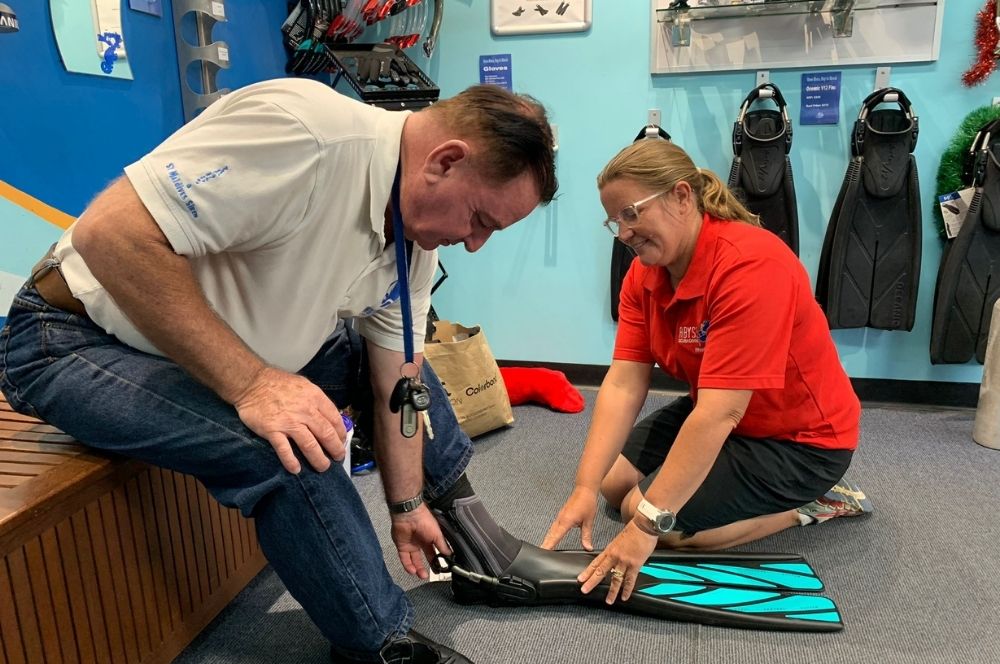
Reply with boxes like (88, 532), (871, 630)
(427, 85), (559, 205)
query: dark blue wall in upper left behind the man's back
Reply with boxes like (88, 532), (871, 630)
(0, 0), (286, 213)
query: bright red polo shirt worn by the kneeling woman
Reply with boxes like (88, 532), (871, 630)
(614, 214), (861, 449)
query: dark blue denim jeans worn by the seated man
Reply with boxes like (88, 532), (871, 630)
(0, 285), (472, 655)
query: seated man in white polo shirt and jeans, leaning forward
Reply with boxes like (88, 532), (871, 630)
(0, 79), (557, 663)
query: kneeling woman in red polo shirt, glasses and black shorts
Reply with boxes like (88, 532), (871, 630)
(542, 141), (868, 601)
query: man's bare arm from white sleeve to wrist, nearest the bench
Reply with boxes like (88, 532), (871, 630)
(73, 180), (265, 403)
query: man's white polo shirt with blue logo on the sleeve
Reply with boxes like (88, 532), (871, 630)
(55, 79), (437, 371)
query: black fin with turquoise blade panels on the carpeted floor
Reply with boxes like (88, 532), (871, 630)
(451, 543), (844, 632)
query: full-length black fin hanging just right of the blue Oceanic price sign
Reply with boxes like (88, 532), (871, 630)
(816, 88), (921, 330)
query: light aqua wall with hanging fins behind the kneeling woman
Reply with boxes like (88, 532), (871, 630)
(435, 0), (1000, 382)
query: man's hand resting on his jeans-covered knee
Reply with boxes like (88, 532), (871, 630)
(233, 367), (348, 474)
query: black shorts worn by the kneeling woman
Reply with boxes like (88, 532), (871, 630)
(622, 396), (854, 535)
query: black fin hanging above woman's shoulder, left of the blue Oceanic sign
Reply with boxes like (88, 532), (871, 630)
(729, 83), (799, 254)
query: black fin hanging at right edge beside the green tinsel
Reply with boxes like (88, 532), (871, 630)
(931, 120), (1000, 364)
